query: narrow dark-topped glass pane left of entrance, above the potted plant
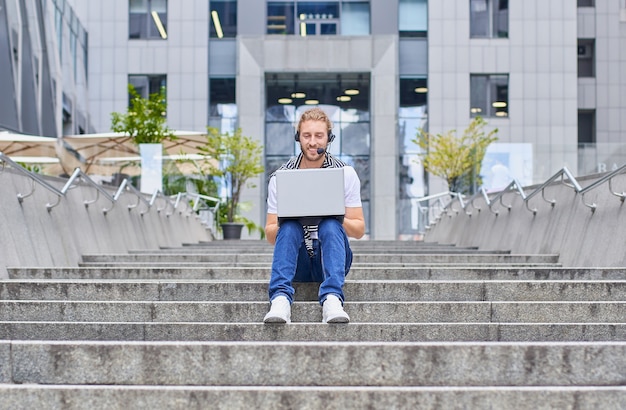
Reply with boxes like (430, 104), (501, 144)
(208, 78), (237, 132)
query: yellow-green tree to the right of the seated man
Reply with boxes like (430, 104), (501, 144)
(411, 117), (498, 193)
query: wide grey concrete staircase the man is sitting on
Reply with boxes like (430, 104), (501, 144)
(0, 241), (626, 409)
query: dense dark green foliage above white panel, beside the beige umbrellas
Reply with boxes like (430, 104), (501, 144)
(111, 84), (176, 145)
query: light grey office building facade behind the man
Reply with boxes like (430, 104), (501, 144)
(9, 0), (626, 239)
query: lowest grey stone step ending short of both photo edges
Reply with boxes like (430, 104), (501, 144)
(82, 253), (558, 265)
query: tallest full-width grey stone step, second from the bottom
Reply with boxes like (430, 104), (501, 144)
(0, 341), (626, 387)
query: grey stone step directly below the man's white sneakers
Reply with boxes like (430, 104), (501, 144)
(0, 321), (626, 342)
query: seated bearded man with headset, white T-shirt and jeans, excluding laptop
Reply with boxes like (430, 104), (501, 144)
(264, 108), (365, 323)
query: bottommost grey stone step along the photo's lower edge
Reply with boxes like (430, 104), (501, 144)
(0, 384), (626, 410)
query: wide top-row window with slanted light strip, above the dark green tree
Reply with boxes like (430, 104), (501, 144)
(128, 0), (167, 40)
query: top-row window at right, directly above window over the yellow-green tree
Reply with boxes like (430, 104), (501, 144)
(470, 0), (509, 38)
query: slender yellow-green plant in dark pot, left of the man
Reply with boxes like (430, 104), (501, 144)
(198, 127), (264, 239)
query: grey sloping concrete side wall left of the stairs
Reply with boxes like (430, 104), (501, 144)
(0, 169), (209, 278)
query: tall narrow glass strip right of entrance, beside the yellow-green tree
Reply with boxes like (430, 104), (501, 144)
(398, 78), (428, 239)
